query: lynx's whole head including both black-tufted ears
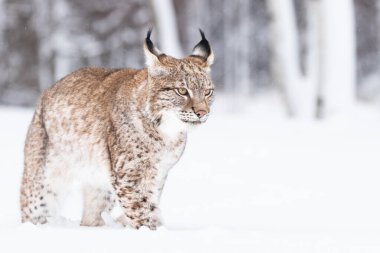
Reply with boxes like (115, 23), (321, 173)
(144, 30), (214, 125)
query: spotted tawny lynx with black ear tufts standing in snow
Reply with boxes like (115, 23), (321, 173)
(20, 29), (214, 230)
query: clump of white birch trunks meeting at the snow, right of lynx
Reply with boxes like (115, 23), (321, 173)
(268, 0), (356, 118)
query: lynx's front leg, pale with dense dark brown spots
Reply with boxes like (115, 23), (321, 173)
(113, 155), (161, 230)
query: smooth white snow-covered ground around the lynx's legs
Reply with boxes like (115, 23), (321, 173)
(0, 94), (380, 253)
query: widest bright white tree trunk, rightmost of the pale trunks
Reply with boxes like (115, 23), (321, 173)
(320, 0), (356, 114)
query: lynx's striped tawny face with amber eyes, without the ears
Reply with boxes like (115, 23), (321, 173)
(150, 59), (214, 124)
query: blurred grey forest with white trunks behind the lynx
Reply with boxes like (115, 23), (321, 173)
(0, 0), (380, 117)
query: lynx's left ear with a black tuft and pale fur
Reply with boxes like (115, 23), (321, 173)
(144, 28), (166, 76)
